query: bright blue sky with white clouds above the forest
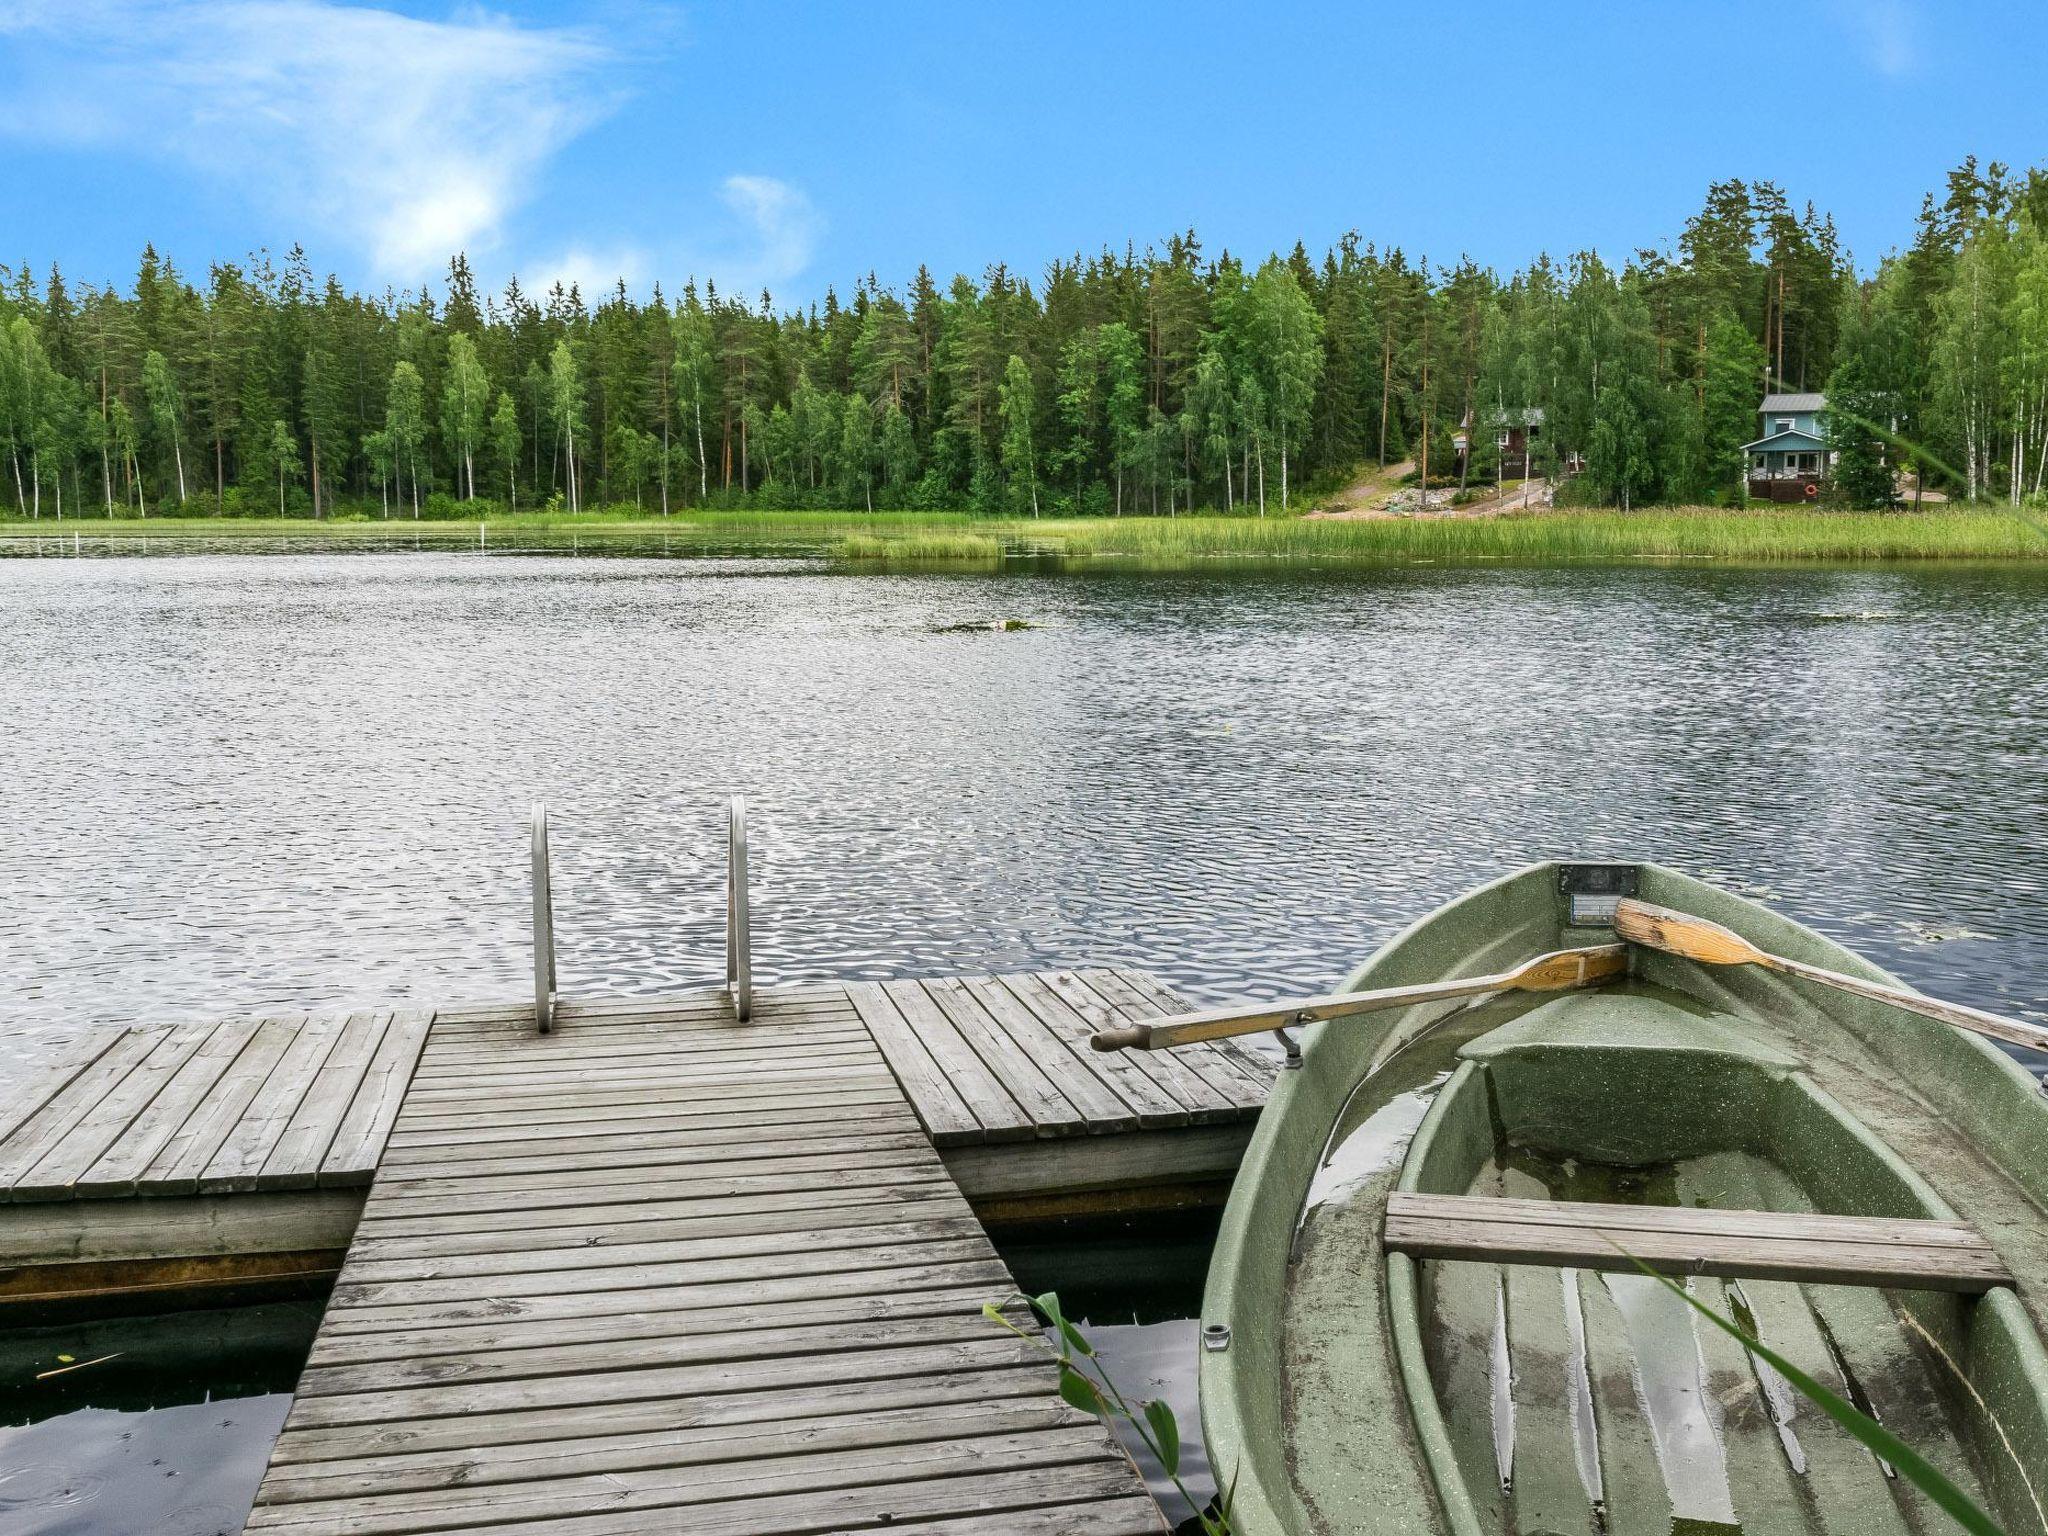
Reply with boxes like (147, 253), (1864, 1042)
(0, 0), (2048, 301)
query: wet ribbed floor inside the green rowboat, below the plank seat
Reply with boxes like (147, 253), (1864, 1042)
(1423, 1147), (1987, 1536)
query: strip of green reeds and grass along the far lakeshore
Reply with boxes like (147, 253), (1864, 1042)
(0, 506), (2048, 565)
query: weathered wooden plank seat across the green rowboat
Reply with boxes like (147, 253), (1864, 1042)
(1384, 1192), (2013, 1292)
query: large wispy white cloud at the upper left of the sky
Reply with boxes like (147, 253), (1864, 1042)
(0, 0), (618, 283)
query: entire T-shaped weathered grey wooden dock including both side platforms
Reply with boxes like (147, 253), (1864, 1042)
(0, 969), (1272, 1536)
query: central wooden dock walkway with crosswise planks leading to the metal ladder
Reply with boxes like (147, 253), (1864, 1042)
(248, 983), (1163, 1536)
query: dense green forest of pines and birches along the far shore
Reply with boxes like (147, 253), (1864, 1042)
(0, 160), (2048, 516)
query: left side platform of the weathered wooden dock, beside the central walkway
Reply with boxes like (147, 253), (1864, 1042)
(0, 1010), (432, 1303)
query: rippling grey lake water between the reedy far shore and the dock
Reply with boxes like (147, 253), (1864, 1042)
(0, 551), (2048, 1530)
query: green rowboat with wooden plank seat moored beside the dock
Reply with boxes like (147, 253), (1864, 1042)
(1202, 864), (2048, 1536)
